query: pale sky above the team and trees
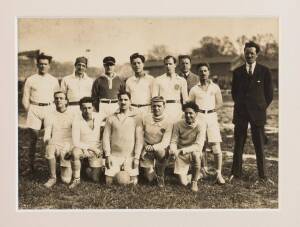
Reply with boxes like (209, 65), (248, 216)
(18, 17), (279, 66)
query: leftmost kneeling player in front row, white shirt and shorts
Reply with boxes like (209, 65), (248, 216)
(44, 91), (75, 188)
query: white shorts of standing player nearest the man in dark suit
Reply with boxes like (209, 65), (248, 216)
(198, 113), (222, 143)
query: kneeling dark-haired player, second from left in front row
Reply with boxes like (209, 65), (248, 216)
(69, 97), (103, 188)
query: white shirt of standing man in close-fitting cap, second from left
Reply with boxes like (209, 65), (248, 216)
(61, 73), (94, 102)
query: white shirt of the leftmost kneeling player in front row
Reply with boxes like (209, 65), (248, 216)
(44, 109), (75, 144)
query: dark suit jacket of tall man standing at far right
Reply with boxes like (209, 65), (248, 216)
(231, 63), (273, 126)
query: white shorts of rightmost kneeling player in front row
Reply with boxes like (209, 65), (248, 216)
(174, 152), (201, 175)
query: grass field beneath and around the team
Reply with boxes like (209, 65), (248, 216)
(18, 96), (278, 209)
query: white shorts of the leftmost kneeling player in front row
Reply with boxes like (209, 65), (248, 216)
(45, 142), (73, 167)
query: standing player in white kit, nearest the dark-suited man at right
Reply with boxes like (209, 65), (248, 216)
(189, 63), (225, 184)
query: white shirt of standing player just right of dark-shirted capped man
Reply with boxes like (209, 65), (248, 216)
(126, 74), (154, 104)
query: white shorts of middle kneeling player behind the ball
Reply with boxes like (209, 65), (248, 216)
(105, 155), (139, 177)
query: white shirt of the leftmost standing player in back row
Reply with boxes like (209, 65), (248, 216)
(22, 74), (59, 109)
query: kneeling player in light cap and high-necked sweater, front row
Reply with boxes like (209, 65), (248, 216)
(140, 96), (173, 187)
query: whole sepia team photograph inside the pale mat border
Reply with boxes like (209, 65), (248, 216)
(15, 16), (281, 211)
